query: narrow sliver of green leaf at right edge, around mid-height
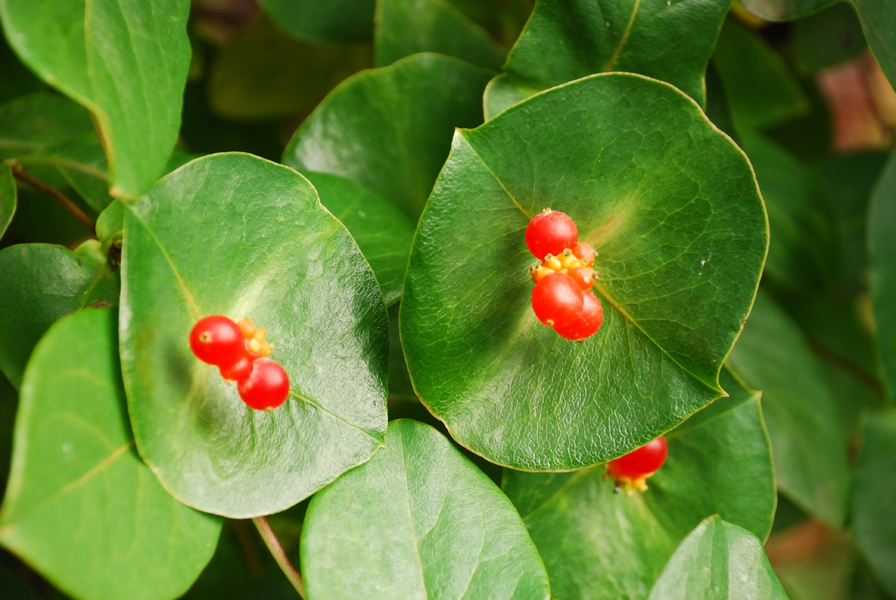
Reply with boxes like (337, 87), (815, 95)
(867, 152), (896, 398)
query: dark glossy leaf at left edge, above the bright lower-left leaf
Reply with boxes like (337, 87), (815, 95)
(0, 241), (119, 388)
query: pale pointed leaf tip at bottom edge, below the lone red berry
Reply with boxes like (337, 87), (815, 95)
(650, 516), (787, 600)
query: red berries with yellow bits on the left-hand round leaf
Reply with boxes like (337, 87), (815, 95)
(190, 315), (289, 410)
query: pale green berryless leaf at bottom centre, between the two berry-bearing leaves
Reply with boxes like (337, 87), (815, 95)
(301, 419), (549, 600)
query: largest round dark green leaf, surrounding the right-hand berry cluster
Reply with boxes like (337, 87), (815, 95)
(401, 74), (768, 471)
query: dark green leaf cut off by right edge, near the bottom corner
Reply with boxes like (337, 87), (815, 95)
(852, 409), (896, 594)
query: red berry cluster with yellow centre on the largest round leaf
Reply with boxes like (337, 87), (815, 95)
(526, 208), (604, 341)
